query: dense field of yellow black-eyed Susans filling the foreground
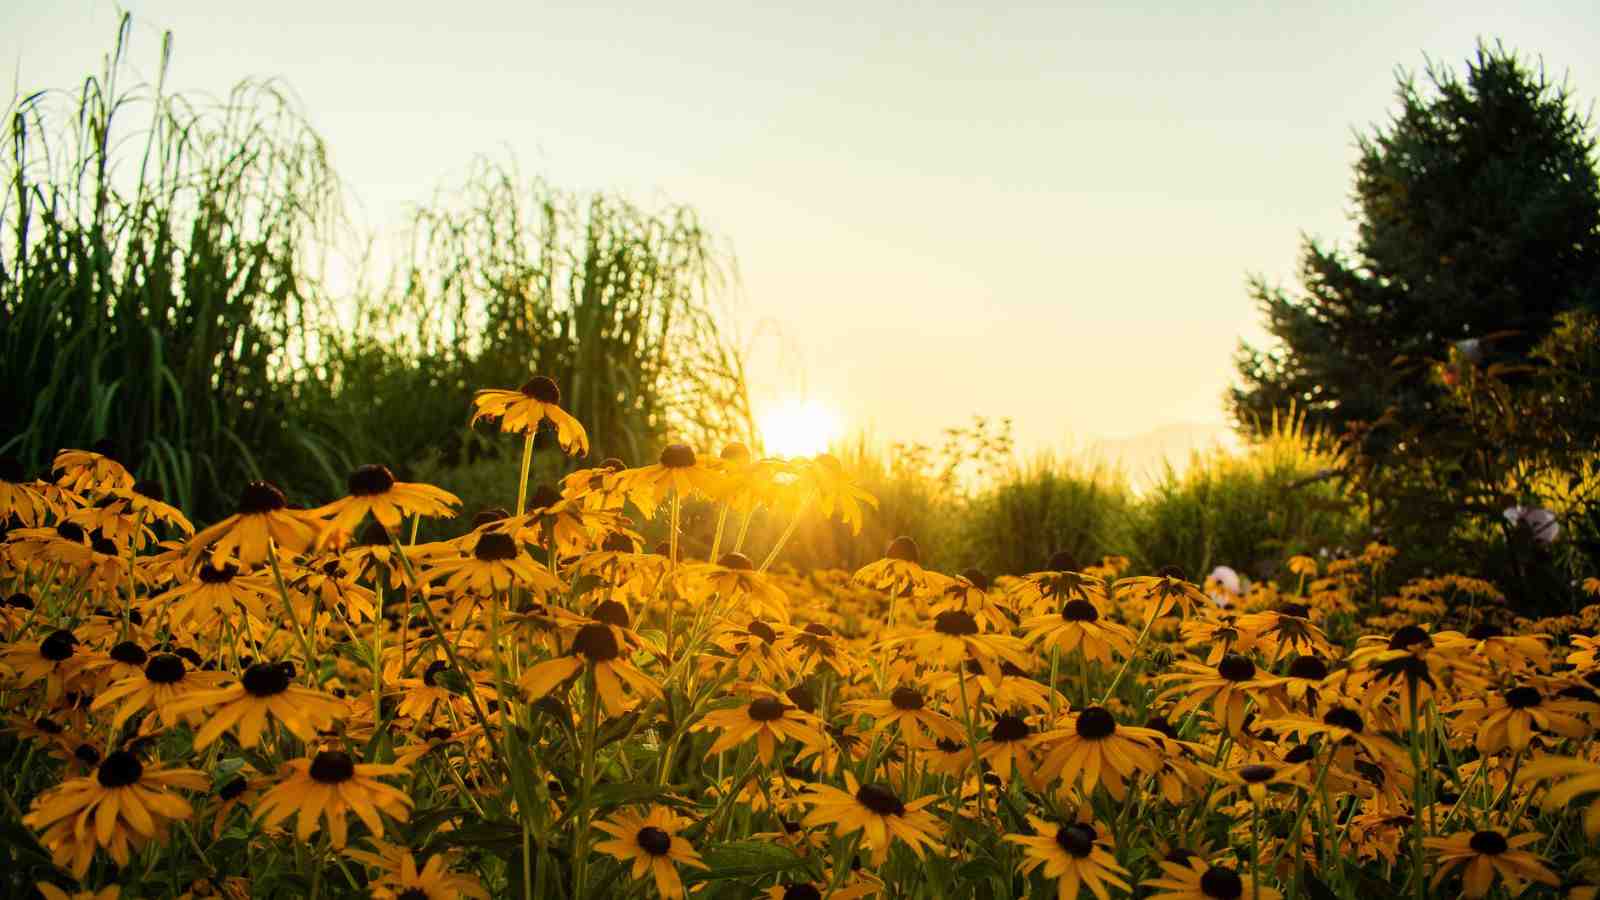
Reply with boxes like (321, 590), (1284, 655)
(0, 378), (1600, 900)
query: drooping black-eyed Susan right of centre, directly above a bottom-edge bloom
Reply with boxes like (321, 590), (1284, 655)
(1038, 706), (1162, 799)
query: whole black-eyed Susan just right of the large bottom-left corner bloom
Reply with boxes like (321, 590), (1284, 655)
(256, 749), (411, 847)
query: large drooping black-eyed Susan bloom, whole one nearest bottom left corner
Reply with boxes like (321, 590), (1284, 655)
(22, 749), (211, 878)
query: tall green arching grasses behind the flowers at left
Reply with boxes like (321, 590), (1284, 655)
(0, 19), (750, 516)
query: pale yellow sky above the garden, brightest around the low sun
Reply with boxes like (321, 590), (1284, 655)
(0, 0), (1600, 447)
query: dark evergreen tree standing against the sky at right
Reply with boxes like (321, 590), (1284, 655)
(1227, 43), (1600, 441)
